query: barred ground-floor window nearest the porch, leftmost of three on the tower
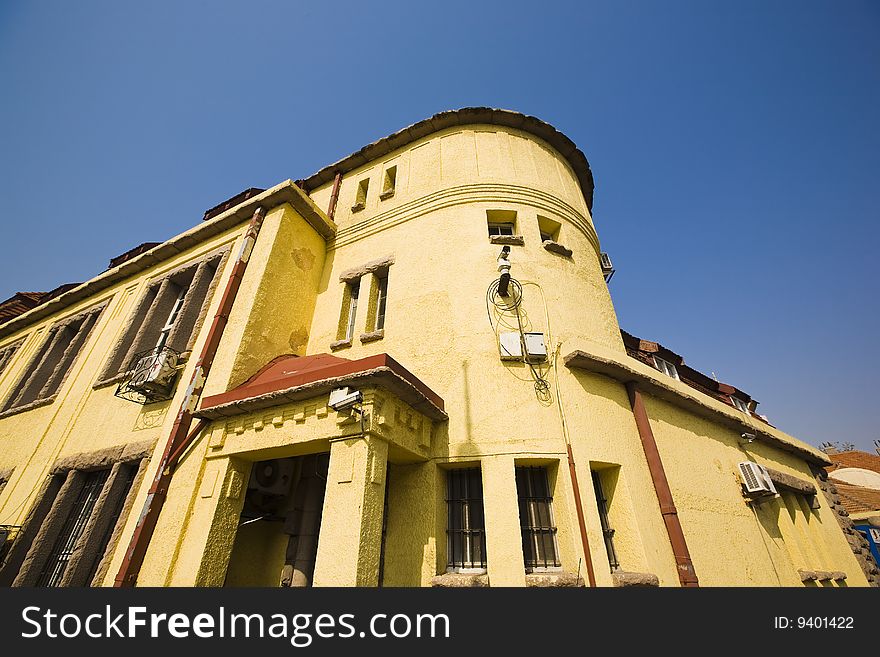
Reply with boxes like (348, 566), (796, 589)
(446, 468), (486, 570)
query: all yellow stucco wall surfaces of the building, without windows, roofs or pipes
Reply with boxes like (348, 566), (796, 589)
(0, 115), (865, 586)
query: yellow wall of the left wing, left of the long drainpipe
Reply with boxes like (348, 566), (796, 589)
(0, 227), (241, 564)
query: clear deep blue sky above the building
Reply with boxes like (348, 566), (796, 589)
(0, 0), (880, 449)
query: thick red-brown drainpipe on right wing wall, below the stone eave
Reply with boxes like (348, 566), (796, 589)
(626, 381), (700, 587)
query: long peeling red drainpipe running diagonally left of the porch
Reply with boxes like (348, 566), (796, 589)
(113, 207), (265, 588)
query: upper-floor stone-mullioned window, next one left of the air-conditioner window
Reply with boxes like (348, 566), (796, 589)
(3, 306), (104, 411)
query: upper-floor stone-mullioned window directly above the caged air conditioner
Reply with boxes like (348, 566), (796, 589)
(99, 254), (223, 383)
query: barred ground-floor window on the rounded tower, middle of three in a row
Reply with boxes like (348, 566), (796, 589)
(516, 466), (561, 571)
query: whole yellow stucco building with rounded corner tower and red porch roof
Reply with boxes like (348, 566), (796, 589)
(0, 108), (876, 587)
